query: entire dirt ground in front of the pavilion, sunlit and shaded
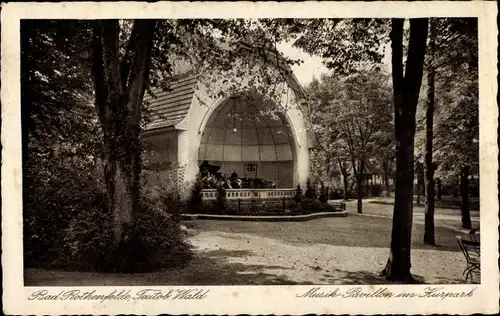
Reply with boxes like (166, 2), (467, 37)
(25, 203), (479, 286)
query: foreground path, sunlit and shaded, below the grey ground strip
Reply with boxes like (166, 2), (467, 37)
(25, 222), (472, 286)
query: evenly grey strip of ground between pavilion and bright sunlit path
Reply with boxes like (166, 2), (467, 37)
(183, 215), (460, 252)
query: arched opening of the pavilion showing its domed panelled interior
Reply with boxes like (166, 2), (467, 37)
(198, 94), (297, 188)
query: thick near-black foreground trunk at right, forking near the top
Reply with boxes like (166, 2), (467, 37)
(382, 19), (428, 282)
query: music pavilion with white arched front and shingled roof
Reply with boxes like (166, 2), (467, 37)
(143, 48), (313, 197)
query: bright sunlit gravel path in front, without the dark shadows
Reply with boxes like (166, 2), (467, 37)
(192, 228), (465, 284)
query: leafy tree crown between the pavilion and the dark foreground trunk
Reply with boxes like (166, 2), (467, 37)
(307, 67), (393, 180)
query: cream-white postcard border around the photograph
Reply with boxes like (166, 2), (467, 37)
(1, 1), (500, 314)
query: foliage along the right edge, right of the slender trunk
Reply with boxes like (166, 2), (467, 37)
(434, 19), (479, 177)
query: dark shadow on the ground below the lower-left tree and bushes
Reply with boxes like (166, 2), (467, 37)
(24, 249), (312, 286)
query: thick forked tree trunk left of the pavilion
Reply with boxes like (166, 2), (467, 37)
(93, 20), (156, 246)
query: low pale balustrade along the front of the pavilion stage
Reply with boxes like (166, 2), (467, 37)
(201, 188), (296, 200)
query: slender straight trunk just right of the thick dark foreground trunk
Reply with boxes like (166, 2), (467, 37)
(424, 20), (436, 245)
